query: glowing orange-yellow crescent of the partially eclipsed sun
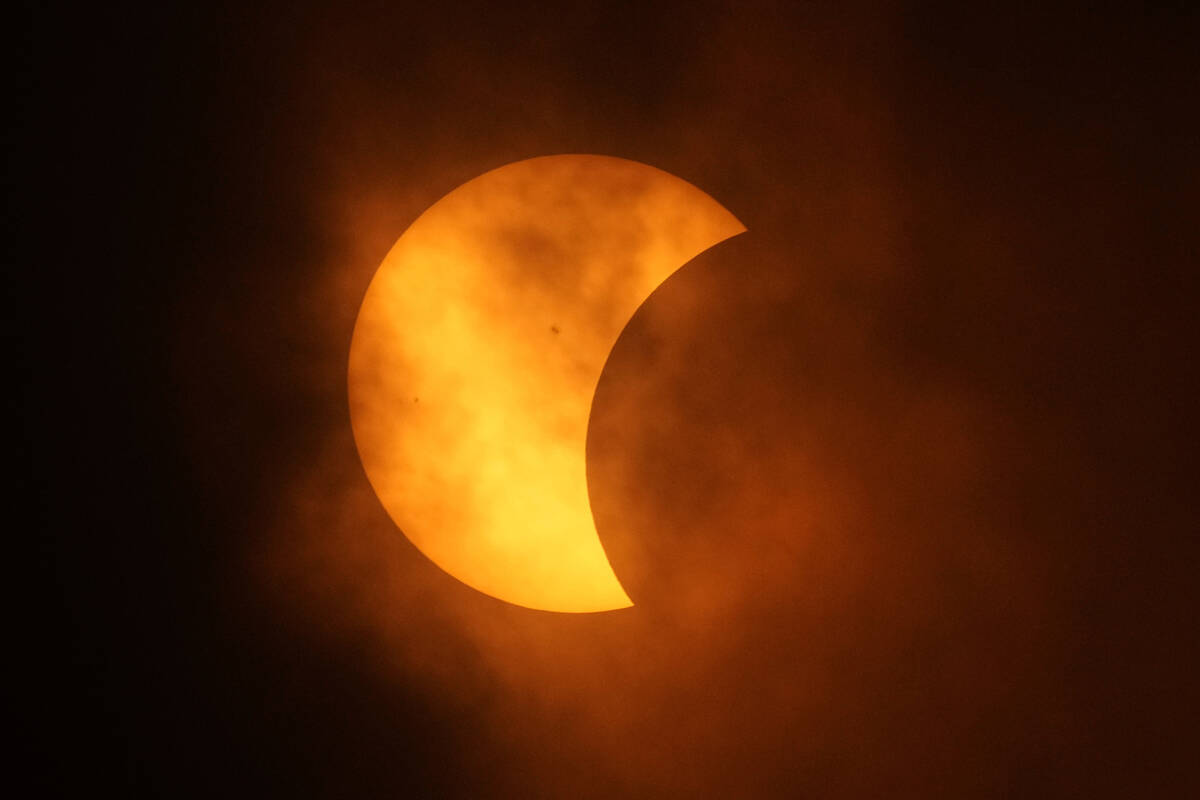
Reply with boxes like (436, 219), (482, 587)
(348, 155), (745, 612)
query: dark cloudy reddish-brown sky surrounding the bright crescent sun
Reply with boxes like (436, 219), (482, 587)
(14, 2), (1200, 798)
